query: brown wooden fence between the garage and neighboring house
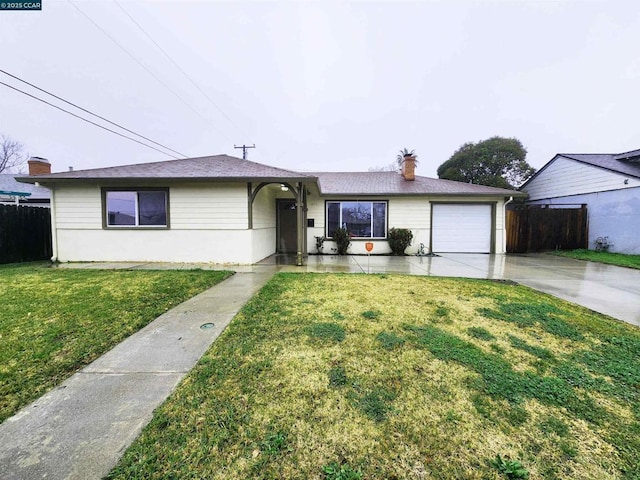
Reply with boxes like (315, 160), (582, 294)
(506, 205), (589, 253)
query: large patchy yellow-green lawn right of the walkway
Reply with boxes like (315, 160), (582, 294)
(109, 274), (640, 480)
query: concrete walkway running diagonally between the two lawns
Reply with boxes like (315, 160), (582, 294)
(0, 267), (278, 480)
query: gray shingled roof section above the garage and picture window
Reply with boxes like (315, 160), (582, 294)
(311, 172), (523, 196)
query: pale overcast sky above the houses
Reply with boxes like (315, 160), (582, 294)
(0, 0), (640, 177)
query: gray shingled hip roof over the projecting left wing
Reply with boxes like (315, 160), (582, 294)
(22, 155), (313, 184)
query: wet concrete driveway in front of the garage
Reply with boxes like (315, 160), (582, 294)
(268, 254), (640, 325)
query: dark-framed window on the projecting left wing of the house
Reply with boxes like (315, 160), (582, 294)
(104, 190), (168, 227)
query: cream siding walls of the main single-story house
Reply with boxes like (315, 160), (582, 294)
(52, 182), (505, 264)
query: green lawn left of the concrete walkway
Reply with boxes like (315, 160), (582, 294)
(0, 264), (230, 421)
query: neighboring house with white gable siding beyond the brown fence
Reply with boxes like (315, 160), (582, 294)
(520, 150), (640, 254)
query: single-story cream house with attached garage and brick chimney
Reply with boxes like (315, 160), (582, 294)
(19, 155), (524, 265)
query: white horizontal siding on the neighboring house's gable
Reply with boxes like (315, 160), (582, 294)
(523, 157), (640, 201)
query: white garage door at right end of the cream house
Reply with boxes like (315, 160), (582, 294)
(431, 204), (491, 253)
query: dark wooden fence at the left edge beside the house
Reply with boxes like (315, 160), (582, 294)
(0, 204), (52, 263)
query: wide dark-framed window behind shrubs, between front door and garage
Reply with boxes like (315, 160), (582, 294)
(326, 201), (387, 238)
